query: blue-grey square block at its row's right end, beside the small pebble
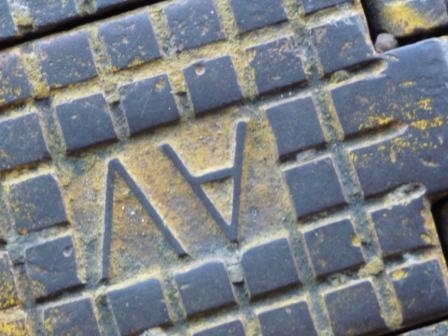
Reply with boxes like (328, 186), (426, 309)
(312, 15), (374, 75)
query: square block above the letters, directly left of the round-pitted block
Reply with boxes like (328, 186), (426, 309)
(120, 75), (180, 135)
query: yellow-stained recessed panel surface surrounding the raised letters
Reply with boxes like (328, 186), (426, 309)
(61, 101), (295, 283)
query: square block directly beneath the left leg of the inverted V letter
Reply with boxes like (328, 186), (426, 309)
(106, 279), (170, 335)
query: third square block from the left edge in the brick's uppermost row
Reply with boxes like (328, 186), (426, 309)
(99, 12), (161, 70)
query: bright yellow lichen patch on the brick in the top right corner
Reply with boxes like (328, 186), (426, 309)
(380, 1), (432, 36)
